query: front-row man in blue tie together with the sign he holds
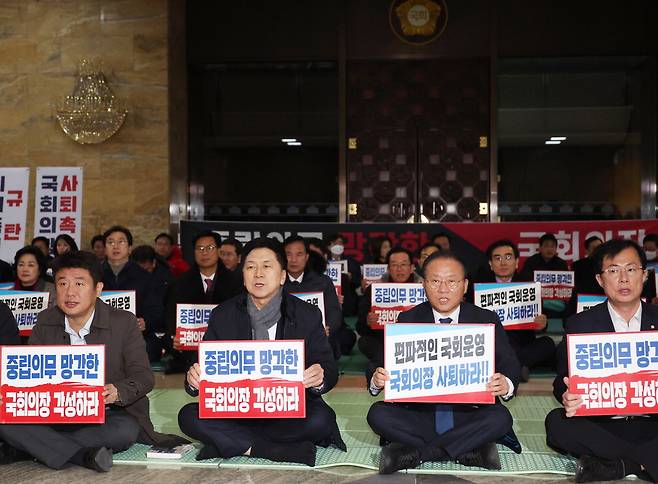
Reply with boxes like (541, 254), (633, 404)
(368, 252), (520, 474)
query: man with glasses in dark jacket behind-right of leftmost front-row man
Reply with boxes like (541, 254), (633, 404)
(101, 225), (164, 362)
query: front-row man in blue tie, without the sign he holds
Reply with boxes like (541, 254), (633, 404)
(367, 252), (520, 474)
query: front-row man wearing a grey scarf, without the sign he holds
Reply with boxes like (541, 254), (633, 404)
(178, 237), (345, 466)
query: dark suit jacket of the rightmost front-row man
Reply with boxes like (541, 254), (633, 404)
(553, 301), (658, 403)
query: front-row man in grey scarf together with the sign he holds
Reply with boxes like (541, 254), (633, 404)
(178, 237), (345, 466)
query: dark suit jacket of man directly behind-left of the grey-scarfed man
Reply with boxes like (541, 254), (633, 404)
(166, 261), (244, 336)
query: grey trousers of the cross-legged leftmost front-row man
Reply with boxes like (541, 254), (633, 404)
(0, 407), (139, 469)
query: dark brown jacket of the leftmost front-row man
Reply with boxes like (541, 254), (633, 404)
(28, 299), (179, 444)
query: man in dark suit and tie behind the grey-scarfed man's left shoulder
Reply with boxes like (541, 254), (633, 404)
(165, 231), (243, 373)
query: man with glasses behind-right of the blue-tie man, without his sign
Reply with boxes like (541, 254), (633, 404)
(466, 240), (555, 382)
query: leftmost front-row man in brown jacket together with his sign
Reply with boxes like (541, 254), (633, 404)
(0, 251), (186, 472)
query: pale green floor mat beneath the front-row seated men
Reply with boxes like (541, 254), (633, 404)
(114, 389), (575, 475)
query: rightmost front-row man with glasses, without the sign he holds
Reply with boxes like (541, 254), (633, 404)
(546, 239), (658, 482)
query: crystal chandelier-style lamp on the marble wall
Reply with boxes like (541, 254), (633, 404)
(57, 59), (127, 144)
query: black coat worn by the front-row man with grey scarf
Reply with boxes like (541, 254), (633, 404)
(186, 292), (338, 398)
